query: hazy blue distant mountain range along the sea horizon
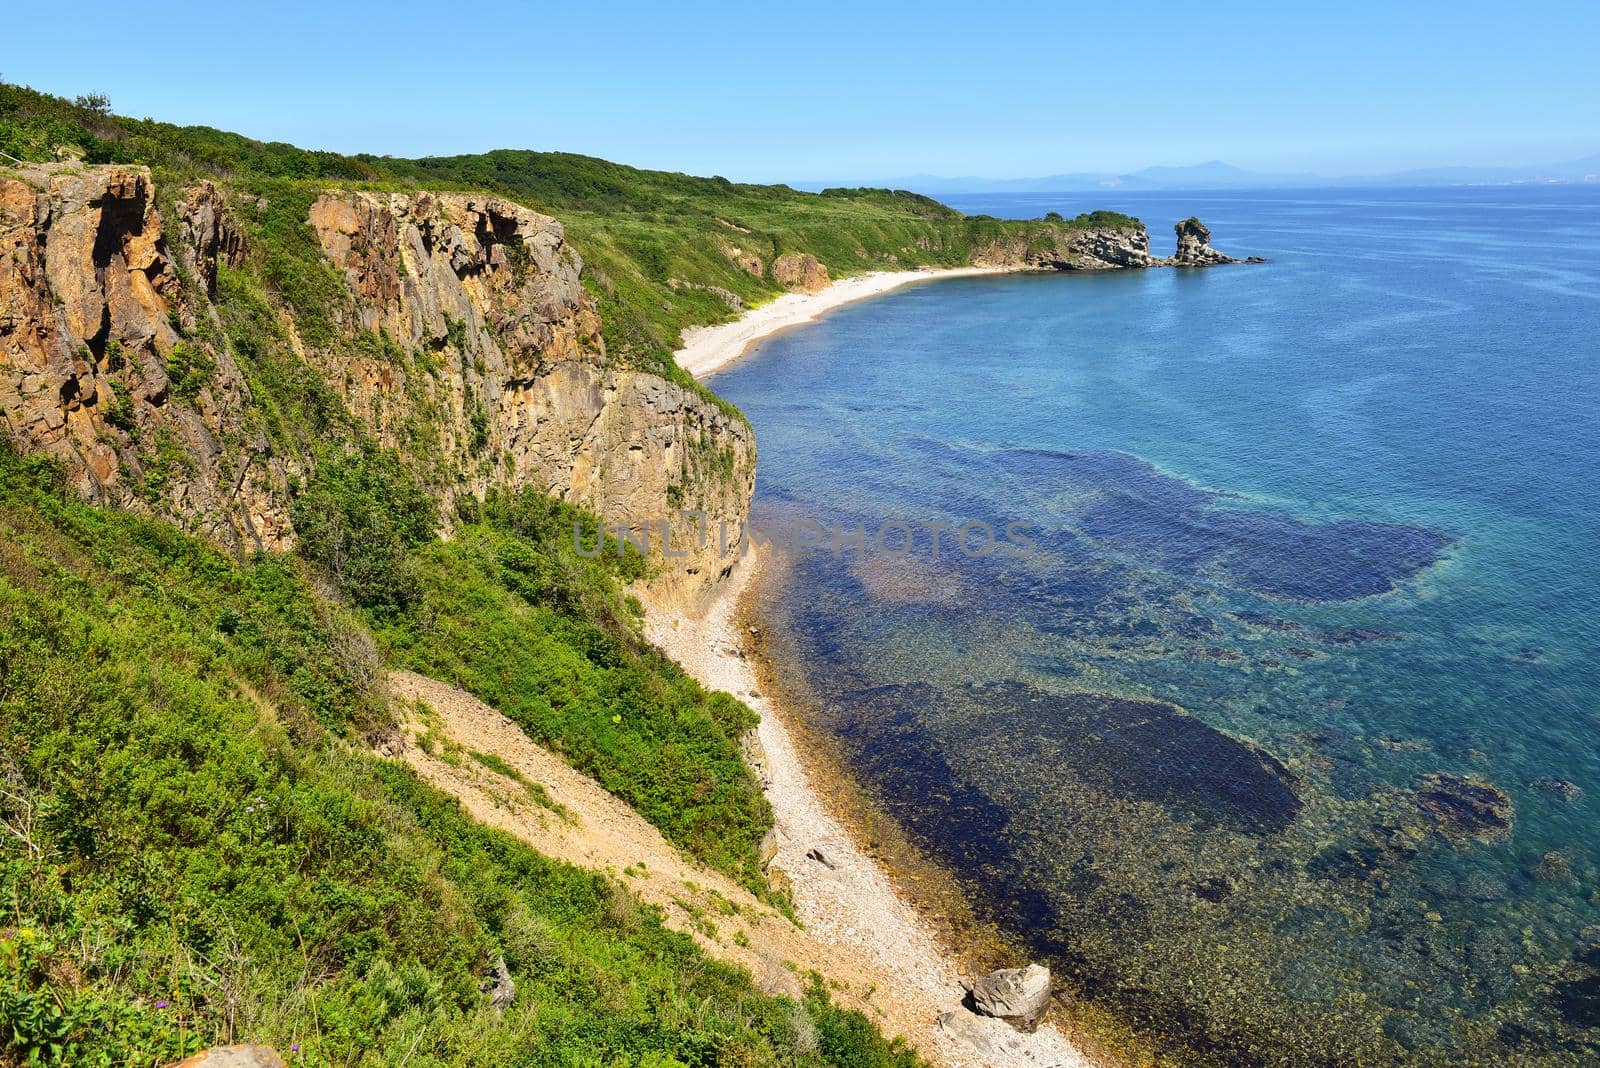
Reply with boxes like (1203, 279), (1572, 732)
(794, 155), (1600, 197)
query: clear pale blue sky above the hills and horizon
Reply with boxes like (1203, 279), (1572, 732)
(0, 0), (1600, 181)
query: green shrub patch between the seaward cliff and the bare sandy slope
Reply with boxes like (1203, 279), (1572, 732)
(374, 491), (771, 892)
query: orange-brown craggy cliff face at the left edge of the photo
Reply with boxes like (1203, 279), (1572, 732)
(0, 165), (293, 548)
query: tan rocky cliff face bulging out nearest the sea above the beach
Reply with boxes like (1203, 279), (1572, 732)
(310, 192), (755, 590)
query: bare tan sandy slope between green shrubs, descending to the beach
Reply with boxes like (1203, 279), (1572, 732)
(384, 671), (1085, 1068)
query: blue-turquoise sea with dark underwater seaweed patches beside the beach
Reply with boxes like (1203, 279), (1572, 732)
(715, 187), (1600, 1063)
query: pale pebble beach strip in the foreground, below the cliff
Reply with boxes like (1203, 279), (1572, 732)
(645, 555), (1096, 1068)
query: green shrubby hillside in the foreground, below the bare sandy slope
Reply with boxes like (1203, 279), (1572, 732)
(0, 446), (910, 1066)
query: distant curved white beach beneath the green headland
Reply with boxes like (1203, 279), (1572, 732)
(674, 267), (1018, 379)
